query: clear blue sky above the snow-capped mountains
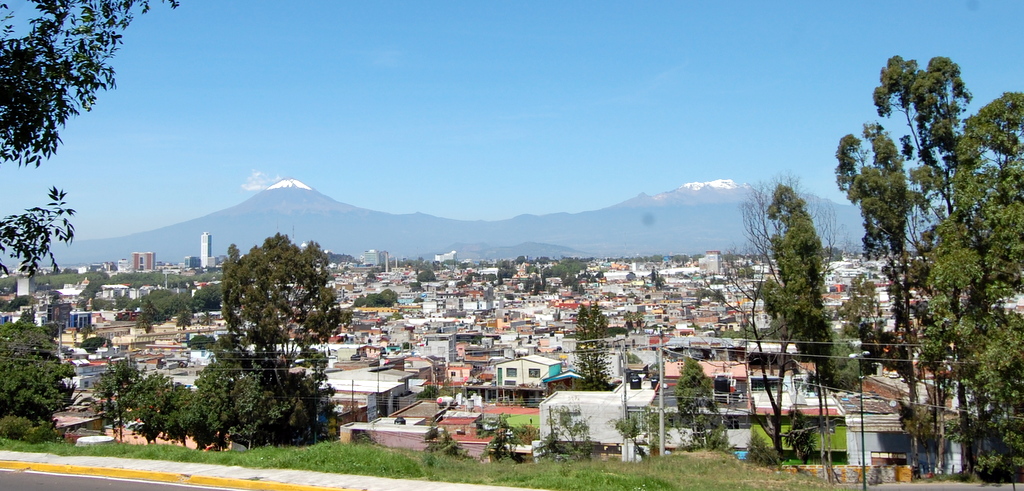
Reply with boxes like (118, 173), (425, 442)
(0, 0), (1024, 239)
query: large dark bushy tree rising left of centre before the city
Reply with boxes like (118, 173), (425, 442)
(204, 234), (342, 446)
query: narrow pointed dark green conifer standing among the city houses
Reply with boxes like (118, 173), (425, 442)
(575, 304), (606, 391)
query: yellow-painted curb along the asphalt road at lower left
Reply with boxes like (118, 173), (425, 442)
(0, 460), (365, 491)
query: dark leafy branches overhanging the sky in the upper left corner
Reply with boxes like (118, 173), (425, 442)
(0, 0), (177, 275)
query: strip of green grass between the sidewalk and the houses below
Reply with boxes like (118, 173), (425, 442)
(0, 440), (827, 491)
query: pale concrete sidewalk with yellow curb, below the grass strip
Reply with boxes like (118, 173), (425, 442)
(0, 451), (544, 491)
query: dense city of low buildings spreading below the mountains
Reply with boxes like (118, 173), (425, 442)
(0, 233), (958, 483)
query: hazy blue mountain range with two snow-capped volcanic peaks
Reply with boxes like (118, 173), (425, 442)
(56, 179), (861, 264)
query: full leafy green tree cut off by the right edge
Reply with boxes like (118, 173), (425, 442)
(934, 92), (1024, 473)
